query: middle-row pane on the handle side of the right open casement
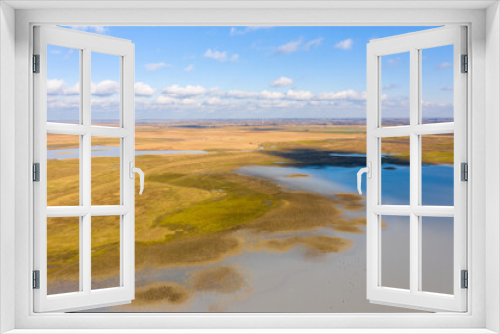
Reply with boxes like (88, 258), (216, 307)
(381, 137), (410, 205)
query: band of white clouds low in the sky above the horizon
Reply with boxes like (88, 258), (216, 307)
(47, 77), (453, 119)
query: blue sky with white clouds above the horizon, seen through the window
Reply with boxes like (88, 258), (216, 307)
(47, 26), (453, 121)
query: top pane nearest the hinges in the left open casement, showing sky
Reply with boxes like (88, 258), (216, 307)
(47, 45), (80, 124)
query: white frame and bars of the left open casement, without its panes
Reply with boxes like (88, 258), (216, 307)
(33, 26), (135, 312)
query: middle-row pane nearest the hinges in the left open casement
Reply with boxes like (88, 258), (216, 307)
(47, 133), (80, 206)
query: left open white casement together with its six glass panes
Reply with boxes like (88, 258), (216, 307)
(34, 27), (139, 312)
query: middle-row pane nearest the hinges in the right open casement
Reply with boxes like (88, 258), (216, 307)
(422, 134), (454, 206)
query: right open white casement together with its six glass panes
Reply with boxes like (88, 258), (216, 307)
(367, 27), (467, 311)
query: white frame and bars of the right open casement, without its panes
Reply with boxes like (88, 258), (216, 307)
(366, 26), (468, 312)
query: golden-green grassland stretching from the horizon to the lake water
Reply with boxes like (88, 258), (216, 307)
(47, 125), (453, 294)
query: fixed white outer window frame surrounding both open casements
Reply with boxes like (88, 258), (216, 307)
(0, 1), (500, 333)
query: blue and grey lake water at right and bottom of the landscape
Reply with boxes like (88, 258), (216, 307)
(76, 152), (453, 312)
